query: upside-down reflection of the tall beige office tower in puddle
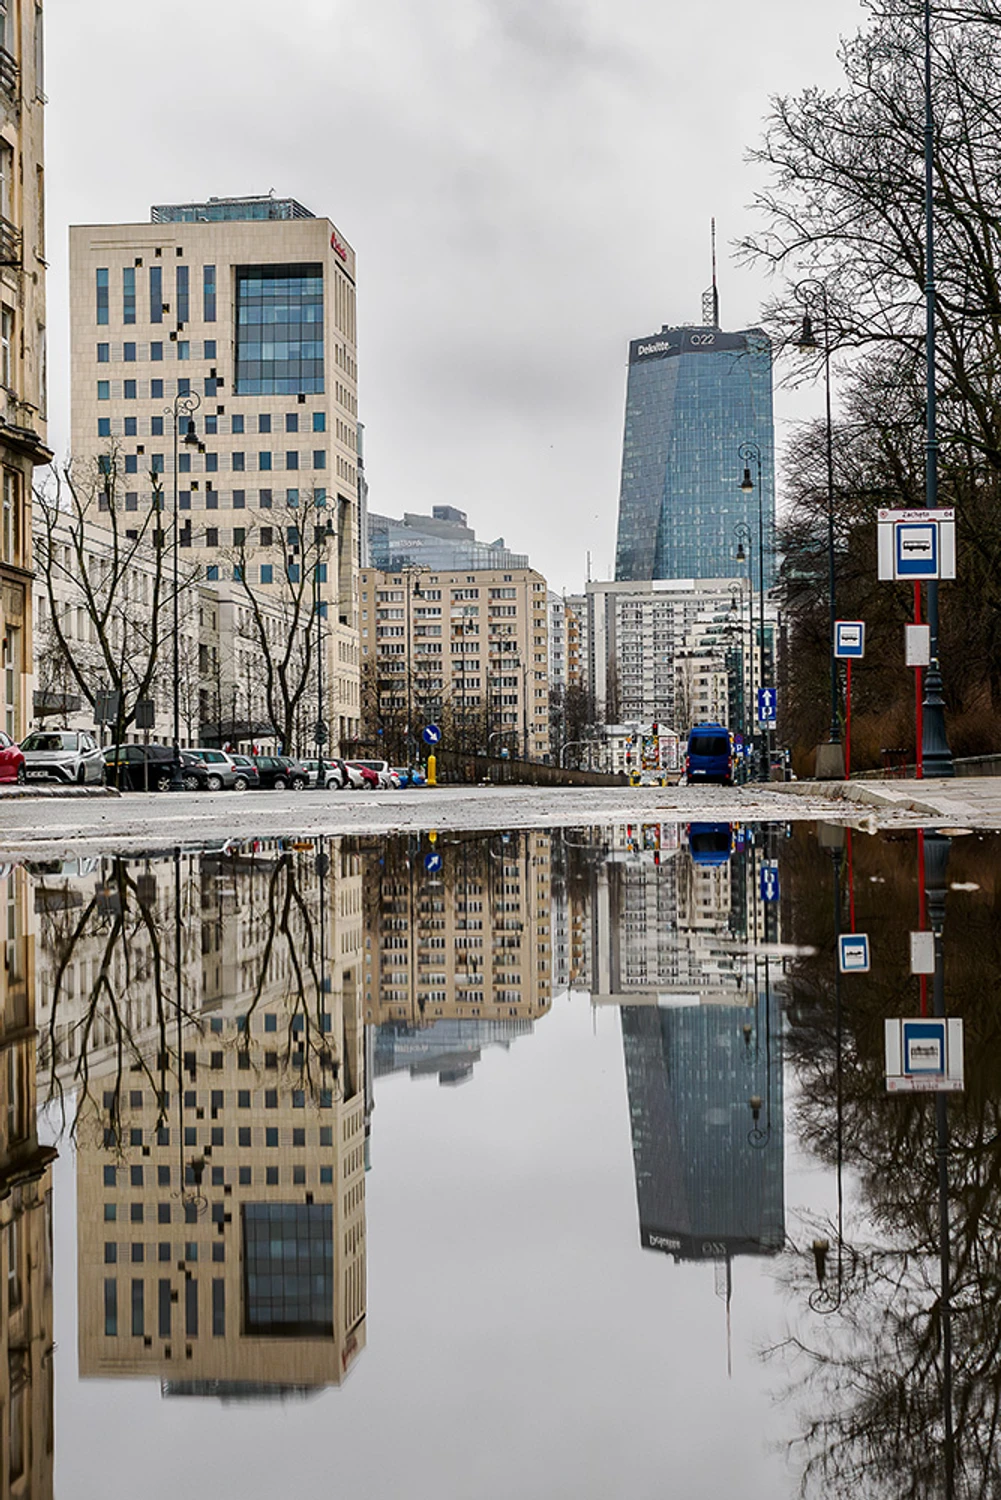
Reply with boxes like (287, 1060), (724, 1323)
(57, 843), (366, 1400)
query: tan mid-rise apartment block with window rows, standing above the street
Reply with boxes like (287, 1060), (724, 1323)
(359, 567), (549, 761)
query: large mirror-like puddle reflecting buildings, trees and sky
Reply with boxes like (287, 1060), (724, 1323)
(0, 824), (1001, 1500)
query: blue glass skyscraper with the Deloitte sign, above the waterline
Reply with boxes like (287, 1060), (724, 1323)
(615, 329), (774, 588)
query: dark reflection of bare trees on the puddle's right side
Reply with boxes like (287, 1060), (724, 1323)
(771, 837), (1001, 1500)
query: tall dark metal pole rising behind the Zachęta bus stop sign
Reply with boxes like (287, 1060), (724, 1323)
(921, 0), (956, 776)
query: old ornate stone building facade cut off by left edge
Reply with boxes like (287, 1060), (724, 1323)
(0, 0), (51, 740)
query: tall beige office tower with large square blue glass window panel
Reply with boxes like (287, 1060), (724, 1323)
(69, 198), (362, 750)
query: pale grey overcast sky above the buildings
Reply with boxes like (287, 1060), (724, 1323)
(47, 0), (861, 590)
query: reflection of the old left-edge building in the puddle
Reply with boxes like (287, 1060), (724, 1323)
(0, 867), (56, 1500)
